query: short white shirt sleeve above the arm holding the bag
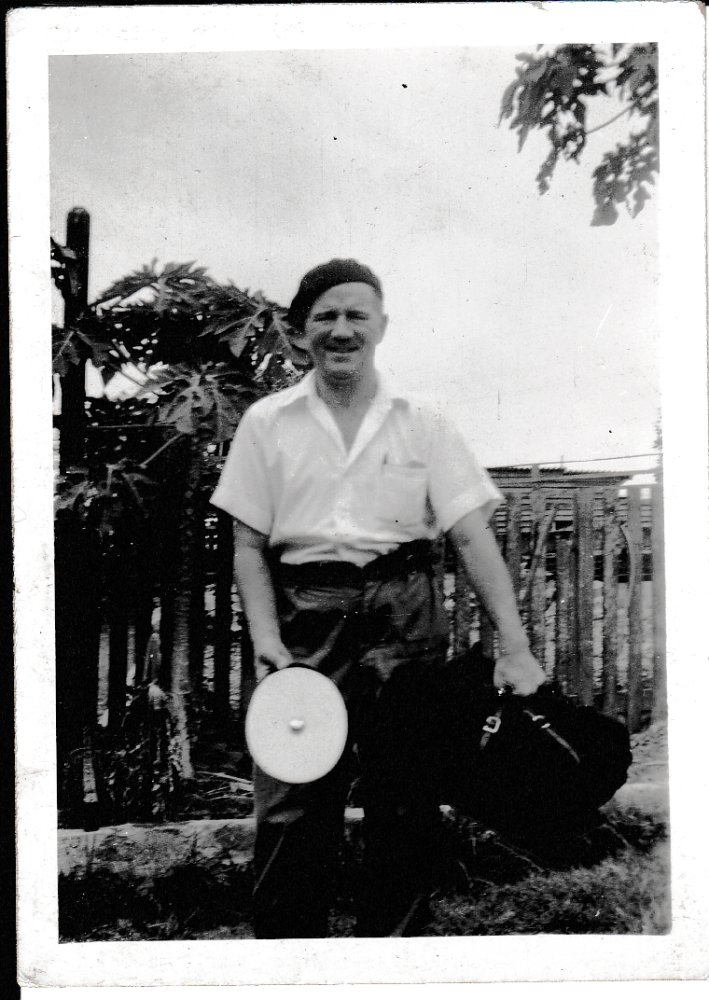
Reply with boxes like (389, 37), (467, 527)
(429, 416), (504, 531)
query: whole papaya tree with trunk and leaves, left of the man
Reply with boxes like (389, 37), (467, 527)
(53, 252), (304, 812)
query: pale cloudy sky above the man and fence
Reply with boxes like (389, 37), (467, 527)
(49, 46), (660, 478)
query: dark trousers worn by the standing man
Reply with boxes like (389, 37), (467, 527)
(254, 556), (448, 938)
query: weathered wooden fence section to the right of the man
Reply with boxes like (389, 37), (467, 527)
(450, 484), (666, 731)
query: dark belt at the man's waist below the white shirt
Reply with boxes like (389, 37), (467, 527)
(273, 538), (433, 587)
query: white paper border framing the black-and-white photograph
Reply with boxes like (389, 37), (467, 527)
(7, 0), (709, 987)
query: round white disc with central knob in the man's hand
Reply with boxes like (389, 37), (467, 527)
(246, 667), (347, 784)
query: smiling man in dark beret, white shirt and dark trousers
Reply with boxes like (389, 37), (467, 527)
(212, 260), (544, 938)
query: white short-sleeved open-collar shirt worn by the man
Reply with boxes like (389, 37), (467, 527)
(211, 372), (502, 566)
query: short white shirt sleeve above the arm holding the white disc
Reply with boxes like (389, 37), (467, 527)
(211, 405), (273, 535)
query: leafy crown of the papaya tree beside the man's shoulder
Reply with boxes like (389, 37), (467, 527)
(52, 245), (300, 560)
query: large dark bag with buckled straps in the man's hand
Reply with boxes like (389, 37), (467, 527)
(433, 644), (632, 843)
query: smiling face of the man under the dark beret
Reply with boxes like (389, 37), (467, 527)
(298, 281), (387, 383)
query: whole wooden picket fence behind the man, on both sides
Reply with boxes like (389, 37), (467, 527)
(55, 468), (665, 822)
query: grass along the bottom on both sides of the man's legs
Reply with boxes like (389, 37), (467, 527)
(59, 810), (671, 941)
